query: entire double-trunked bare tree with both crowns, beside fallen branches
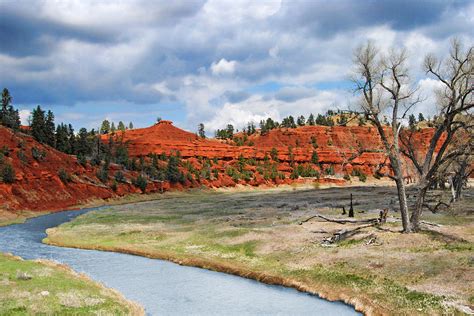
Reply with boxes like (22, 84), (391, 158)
(353, 40), (474, 232)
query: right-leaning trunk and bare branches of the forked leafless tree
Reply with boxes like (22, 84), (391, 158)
(402, 39), (474, 231)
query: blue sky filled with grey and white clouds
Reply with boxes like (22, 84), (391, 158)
(0, 0), (474, 134)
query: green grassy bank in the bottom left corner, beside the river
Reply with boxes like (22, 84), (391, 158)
(0, 254), (144, 315)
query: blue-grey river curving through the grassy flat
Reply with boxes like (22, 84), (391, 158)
(0, 209), (359, 315)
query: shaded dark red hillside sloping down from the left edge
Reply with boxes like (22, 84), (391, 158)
(0, 126), (168, 210)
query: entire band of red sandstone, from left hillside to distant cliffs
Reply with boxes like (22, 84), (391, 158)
(0, 121), (442, 210)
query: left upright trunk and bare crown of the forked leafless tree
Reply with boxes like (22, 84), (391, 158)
(353, 41), (420, 232)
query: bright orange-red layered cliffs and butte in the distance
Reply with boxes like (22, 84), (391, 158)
(106, 121), (433, 174)
